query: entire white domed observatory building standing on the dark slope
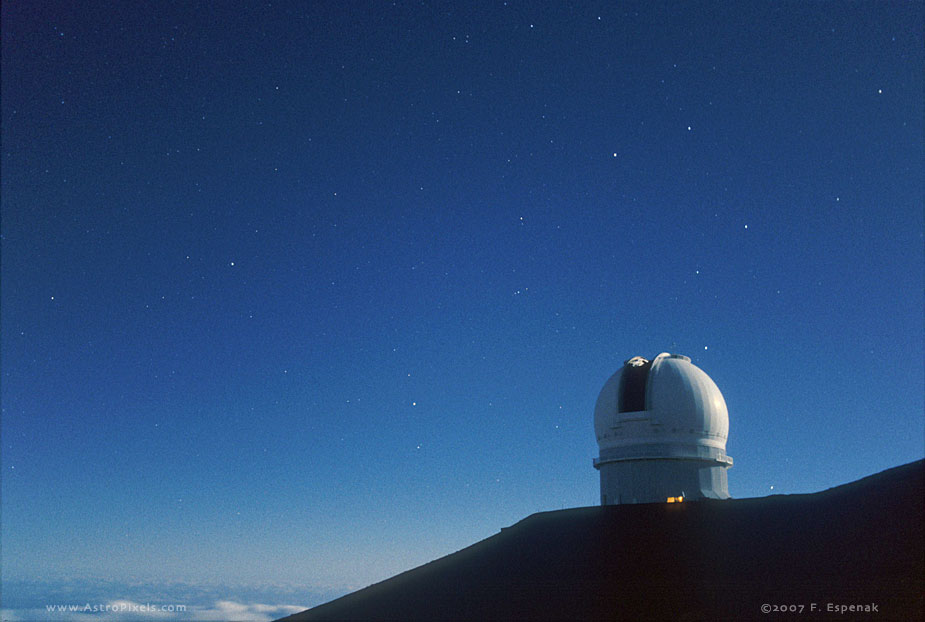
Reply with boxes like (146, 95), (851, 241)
(594, 352), (732, 505)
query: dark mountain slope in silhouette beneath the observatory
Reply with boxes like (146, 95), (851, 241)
(284, 460), (925, 622)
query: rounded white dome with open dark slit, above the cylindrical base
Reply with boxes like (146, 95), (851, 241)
(594, 352), (731, 464)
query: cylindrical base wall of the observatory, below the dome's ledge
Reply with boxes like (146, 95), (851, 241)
(598, 459), (729, 505)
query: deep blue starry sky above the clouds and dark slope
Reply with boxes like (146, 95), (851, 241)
(2, 0), (923, 620)
